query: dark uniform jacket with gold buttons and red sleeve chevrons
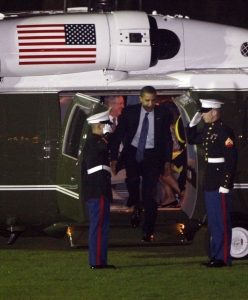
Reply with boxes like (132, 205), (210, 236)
(188, 119), (237, 191)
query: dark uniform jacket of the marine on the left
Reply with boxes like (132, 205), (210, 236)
(82, 134), (112, 200)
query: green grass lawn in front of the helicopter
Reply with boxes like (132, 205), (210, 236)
(0, 228), (248, 300)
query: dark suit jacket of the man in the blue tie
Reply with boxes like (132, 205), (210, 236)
(110, 104), (173, 169)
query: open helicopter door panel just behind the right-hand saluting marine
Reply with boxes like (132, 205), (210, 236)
(173, 94), (205, 219)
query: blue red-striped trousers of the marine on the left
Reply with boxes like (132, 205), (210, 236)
(87, 196), (110, 266)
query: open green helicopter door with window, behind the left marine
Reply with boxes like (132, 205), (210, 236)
(57, 93), (107, 222)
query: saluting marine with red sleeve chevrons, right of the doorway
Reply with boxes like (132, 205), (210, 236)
(188, 99), (237, 267)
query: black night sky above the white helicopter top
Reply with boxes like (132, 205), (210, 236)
(0, 0), (248, 28)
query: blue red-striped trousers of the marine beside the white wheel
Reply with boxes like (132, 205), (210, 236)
(204, 191), (232, 266)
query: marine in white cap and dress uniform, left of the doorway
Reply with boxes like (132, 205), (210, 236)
(82, 111), (115, 269)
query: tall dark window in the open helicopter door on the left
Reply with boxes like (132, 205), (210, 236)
(63, 106), (85, 158)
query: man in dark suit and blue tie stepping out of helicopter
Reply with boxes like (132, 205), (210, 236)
(111, 86), (172, 242)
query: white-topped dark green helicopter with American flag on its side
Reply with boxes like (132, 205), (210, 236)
(0, 0), (248, 258)
